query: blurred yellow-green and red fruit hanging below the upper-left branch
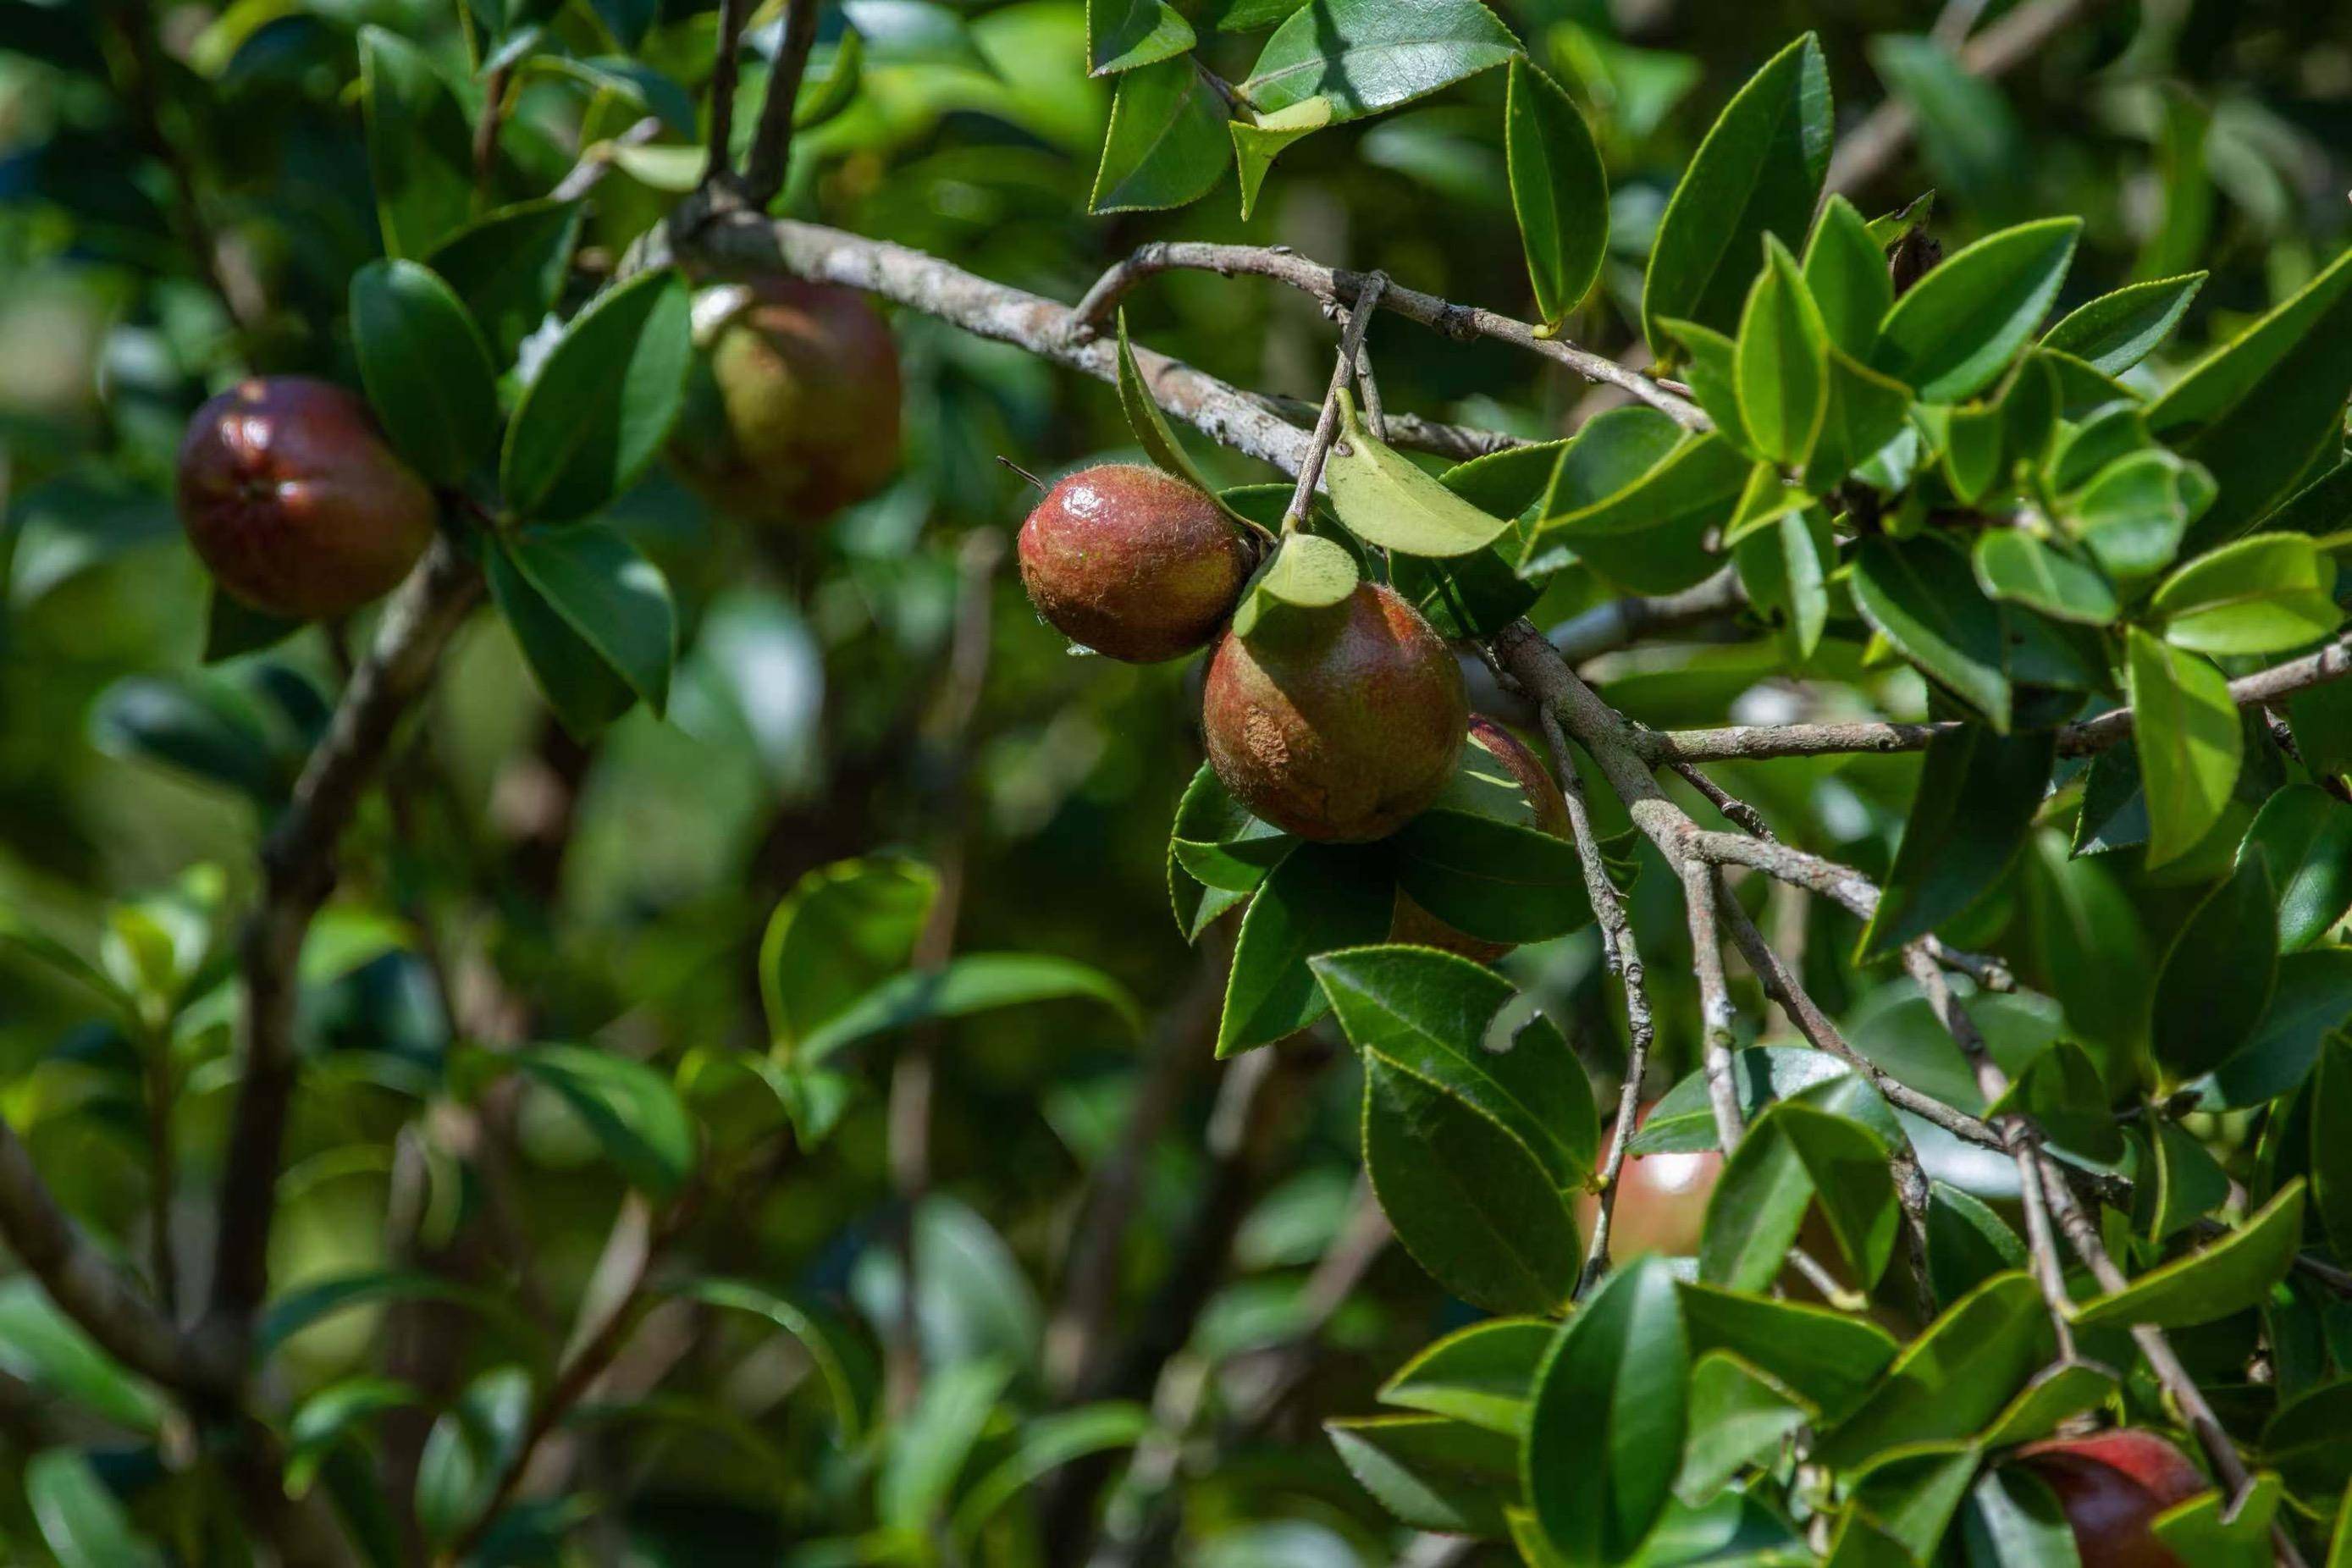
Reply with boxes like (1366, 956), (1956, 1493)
(671, 278), (898, 527)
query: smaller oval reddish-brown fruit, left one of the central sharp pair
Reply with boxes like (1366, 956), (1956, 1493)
(1021, 463), (1256, 665)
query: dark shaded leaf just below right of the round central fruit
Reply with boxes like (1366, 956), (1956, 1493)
(1390, 806), (1593, 942)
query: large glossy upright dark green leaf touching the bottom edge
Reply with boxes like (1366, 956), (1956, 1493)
(1521, 1257), (1691, 1568)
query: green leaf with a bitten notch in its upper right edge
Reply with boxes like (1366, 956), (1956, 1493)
(1310, 947), (1599, 1190)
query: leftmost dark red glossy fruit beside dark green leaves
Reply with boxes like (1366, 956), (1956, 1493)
(179, 376), (435, 621)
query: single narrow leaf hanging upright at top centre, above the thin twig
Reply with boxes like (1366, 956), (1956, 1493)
(1503, 54), (1609, 327)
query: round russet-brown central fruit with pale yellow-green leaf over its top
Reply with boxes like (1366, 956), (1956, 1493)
(1202, 583), (1470, 844)
